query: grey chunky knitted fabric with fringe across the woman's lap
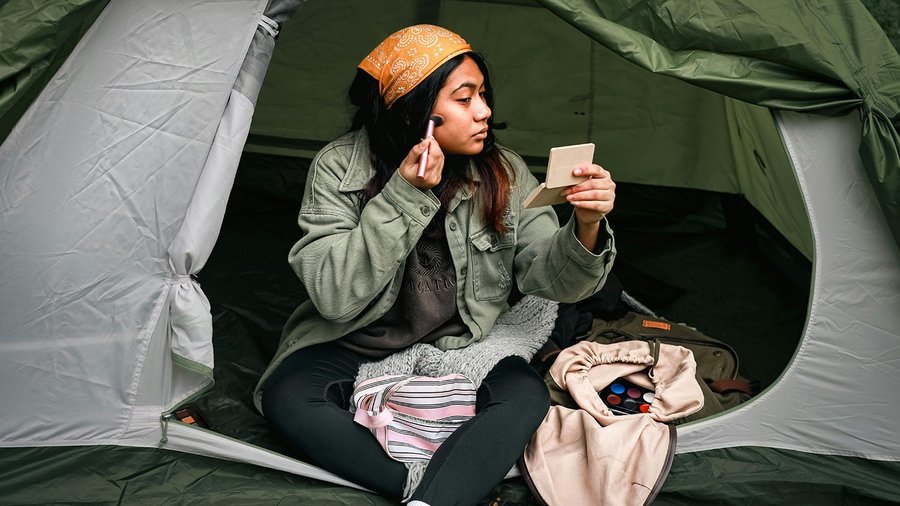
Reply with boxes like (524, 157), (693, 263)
(356, 295), (559, 501)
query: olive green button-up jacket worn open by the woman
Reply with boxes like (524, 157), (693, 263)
(256, 131), (615, 409)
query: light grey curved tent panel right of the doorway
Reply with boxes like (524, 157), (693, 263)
(677, 112), (900, 461)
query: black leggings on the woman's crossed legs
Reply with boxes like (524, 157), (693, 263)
(262, 343), (550, 506)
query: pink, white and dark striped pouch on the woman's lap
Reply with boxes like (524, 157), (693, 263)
(351, 374), (476, 462)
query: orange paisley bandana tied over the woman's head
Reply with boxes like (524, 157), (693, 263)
(359, 25), (472, 107)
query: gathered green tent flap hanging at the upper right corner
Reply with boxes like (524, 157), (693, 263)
(538, 0), (900, 253)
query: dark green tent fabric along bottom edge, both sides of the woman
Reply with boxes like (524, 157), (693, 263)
(0, 446), (900, 506)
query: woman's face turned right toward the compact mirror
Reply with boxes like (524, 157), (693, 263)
(432, 57), (491, 155)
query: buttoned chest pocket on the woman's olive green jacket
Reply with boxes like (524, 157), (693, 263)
(469, 229), (516, 300)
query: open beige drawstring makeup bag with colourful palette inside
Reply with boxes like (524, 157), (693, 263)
(519, 341), (703, 506)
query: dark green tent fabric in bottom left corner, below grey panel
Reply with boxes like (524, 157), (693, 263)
(0, 446), (398, 506)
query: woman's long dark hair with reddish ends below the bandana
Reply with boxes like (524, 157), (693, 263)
(349, 52), (514, 232)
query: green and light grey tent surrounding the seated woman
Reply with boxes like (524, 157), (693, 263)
(0, 0), (900, 504)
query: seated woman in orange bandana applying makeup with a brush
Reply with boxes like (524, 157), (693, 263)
(257, 25), (615, 505)
